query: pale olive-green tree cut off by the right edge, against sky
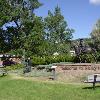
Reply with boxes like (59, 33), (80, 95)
(91, 19), (100, 50)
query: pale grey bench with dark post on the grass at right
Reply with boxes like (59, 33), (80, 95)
(84, 74), (100, 89)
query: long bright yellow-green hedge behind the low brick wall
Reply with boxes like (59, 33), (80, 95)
(32, 55), (73, 66)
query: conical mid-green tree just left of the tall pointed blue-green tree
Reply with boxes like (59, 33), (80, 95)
(24, 16), (45, 56)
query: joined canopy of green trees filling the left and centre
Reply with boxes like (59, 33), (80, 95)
(0, 0), (74, 56)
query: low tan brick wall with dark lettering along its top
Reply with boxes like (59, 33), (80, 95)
(56, 63), (100, 82)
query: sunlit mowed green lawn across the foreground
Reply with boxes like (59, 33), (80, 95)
(0, 76), (100, 100)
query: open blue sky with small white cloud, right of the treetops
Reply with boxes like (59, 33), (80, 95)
(35, 0), (100, 39)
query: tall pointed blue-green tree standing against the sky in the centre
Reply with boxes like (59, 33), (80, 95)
(44, 6), (74, 53)
